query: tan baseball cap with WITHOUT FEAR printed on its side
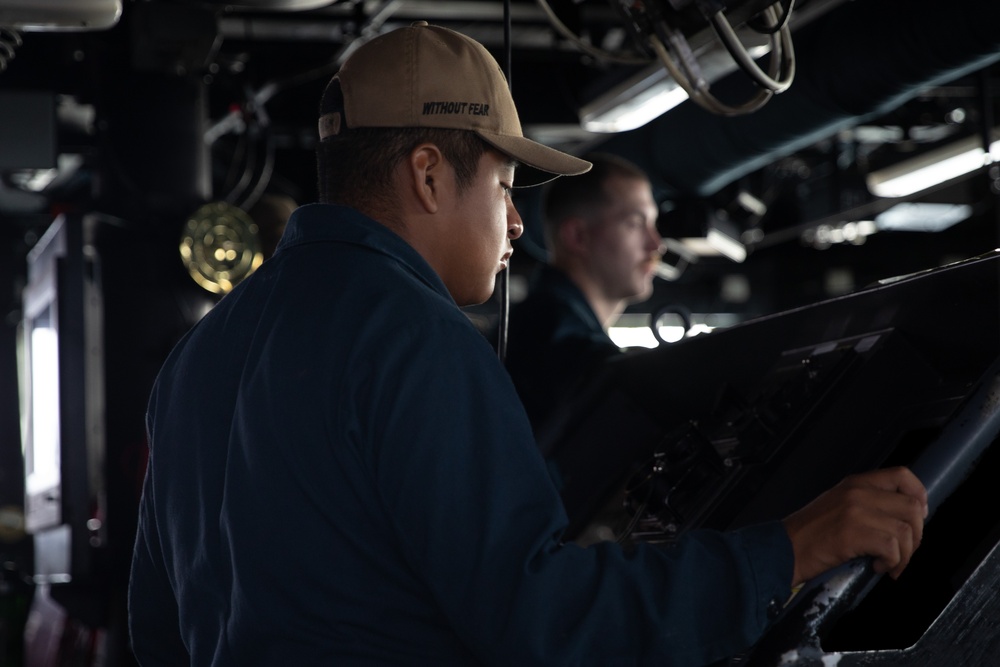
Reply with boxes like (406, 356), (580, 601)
(319, 21), (591, 186)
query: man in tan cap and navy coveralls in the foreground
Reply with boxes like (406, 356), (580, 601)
(129, 23), (924, 667)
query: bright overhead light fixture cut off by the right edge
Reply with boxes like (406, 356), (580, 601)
(867, 128), (1000, 197)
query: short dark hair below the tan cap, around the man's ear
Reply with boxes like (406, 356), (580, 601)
(316, 127), (491, 210)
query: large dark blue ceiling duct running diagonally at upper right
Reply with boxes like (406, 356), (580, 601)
(601, 0), (1000, 196)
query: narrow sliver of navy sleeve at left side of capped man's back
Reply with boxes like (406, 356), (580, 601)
(128, 410), (191, 667)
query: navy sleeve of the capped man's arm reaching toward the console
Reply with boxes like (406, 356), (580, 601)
(350, 321), (792, 665)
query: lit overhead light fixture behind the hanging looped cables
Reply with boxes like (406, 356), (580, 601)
(580, 45), (770, 132)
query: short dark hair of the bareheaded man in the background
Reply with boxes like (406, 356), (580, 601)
(543, 153), (649, 247)
